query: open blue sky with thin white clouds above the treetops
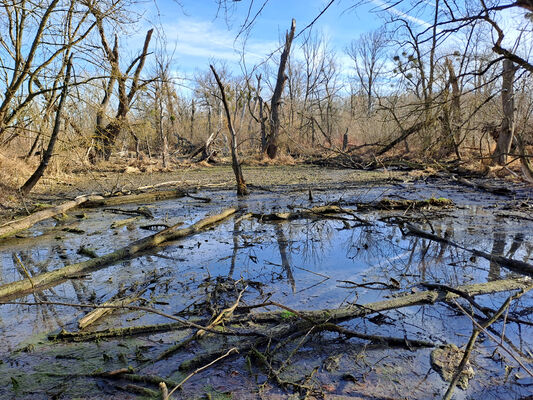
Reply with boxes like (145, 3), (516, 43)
(134, 0), (523, 86)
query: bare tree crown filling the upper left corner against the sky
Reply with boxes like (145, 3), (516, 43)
(0, 0), (95, 144)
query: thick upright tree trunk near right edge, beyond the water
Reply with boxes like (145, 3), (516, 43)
(492, 59), (516, 165)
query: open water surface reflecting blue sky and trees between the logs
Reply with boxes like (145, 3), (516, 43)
(0, 193), (533, 400)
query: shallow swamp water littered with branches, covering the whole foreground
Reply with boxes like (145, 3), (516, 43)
(0, 181), (533, 399)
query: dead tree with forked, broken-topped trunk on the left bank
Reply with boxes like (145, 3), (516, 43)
(90, 9), (154, 163)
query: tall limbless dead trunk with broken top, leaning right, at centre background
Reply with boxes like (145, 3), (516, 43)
(262, 19), (296, 159)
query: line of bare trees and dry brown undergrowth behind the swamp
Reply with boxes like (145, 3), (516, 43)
(0, 0), (533, 193)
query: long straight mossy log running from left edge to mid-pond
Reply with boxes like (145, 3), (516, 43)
(0, 208), (237, 299)
